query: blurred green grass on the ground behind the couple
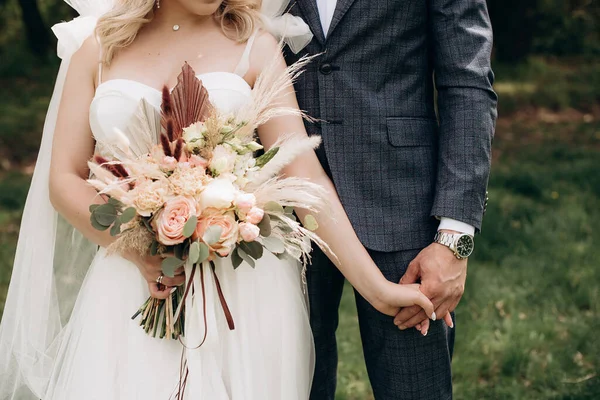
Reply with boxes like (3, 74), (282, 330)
(0, 55), (600, 400)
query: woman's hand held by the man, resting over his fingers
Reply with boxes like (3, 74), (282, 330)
(370, 280), (435, 320)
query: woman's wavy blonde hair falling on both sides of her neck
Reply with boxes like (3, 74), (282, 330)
(96, 0), (262, 65)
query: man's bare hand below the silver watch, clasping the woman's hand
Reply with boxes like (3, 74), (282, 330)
(394, 234), (467, 330)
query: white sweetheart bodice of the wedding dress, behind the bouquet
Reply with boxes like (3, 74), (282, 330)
(90, 72), (252, 141)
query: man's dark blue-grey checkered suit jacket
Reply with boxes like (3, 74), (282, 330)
(286, 0), (496, 252)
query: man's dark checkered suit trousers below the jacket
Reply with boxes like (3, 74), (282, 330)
(307, 245), (456, 400)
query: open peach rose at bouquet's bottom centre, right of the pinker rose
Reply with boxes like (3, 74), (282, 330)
(193, 208), (238, 257)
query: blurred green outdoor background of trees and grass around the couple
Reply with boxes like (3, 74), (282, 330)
(0, 0), (600, 400)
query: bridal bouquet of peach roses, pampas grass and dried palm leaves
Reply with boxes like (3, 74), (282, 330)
(88, 59), (325, 339)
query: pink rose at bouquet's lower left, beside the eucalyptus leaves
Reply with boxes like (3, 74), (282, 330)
(152, 196), (196, 246)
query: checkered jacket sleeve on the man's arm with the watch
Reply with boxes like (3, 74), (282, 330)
(428, 0), (497, 230)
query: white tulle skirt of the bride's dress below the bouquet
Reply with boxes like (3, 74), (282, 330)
(44, 250), (314, 400)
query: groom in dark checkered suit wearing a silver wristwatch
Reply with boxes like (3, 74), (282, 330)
(286, 0), (496, 400)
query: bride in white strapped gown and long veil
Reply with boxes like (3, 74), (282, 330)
(0, 0), (435, 400)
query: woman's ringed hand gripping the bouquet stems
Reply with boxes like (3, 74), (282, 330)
(125, 254), (185, 299)
